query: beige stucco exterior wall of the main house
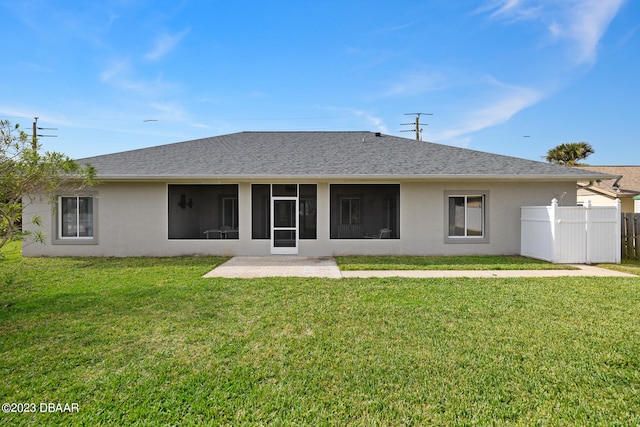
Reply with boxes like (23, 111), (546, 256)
(23, 182), (576, 257)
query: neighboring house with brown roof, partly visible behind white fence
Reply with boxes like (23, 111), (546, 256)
(577, 166), (640, 213)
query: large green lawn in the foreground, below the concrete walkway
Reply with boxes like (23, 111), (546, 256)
(0, 242), (640, 426)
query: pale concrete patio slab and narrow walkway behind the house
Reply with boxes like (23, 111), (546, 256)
(202, 255), (638, 279)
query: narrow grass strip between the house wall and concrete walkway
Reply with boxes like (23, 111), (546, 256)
(336, 256), (576, 270)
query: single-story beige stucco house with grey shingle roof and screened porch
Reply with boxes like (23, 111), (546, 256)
(23, 132), (613, 256)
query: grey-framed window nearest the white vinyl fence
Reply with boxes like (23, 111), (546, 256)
(445, 192), (488, 243)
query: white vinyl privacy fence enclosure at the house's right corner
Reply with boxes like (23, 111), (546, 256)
(520, 199), (621, 264)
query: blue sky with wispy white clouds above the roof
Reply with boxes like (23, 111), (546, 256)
(0, 0), (640, 165)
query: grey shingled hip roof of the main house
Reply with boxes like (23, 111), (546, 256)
(78, 132), (610, 181)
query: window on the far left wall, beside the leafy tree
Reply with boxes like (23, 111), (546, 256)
(58, 196), (93, 239)
